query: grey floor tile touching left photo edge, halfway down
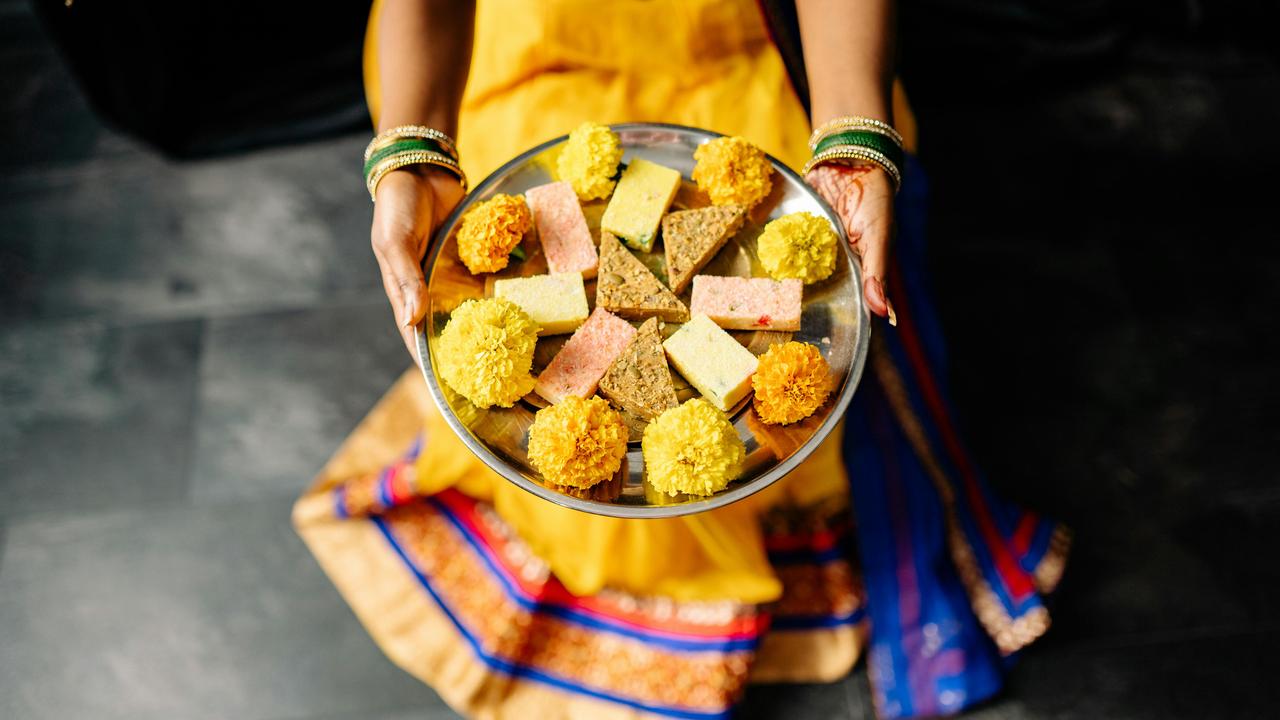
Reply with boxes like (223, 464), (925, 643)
(0, 320), (202, 518)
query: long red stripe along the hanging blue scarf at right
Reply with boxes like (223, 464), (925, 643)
(890, 263), (1036, 602)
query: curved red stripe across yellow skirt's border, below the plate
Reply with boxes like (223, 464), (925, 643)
(435, 488), (768, 639)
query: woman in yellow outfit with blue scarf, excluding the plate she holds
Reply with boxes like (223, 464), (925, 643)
(294, 0), (1068, 717)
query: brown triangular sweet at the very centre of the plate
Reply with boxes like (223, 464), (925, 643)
(595, 231), (689, 323)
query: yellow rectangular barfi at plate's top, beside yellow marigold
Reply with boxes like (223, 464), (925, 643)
(600, 158), (681, 252)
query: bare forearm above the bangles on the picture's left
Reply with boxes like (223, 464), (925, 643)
(378, 0), (475, 136)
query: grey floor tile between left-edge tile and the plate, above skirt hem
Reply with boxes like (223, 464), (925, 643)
(192, 301), (412, 501)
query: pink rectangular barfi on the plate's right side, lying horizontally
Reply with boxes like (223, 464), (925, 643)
(689, 275), (804, 332)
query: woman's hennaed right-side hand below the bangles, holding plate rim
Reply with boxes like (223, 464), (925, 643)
(805, 163), (897, 325)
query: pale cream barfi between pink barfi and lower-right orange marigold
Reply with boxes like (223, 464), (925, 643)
(662, 315), (756, 413)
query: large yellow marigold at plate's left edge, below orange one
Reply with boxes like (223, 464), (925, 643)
(435, 297), (538, 407)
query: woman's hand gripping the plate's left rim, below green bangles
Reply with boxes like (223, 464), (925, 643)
(370, 165), (462, 359)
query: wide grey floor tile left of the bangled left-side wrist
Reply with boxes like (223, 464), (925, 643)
(0, 137), (381, 324)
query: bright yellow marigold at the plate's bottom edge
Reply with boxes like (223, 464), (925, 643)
(640, 397), (746, 496)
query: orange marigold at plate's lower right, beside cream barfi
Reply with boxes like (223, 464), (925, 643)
(751, 342), (832, 425)
